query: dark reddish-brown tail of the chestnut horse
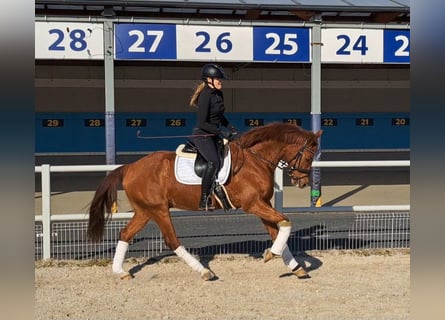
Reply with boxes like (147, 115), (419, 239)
(87, 165), (126, 241)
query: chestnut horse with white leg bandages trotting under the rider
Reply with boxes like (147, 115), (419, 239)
(88, 123), (322, 280)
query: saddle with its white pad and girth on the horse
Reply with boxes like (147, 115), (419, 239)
(175, 141), (235, 211)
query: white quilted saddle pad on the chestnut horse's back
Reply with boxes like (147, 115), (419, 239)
(175, 149), (232, 185)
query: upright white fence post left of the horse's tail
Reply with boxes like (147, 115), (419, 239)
(42, 164), (51, 260)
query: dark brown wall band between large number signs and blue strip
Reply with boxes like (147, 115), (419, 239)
(35, 62), (410, 112)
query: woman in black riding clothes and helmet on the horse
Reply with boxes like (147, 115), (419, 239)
(190, 63), (238, 210)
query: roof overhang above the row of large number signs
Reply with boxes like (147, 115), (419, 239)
(35, 0), (410, 23)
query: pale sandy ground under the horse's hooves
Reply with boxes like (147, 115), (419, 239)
(35, 249), (410, 320)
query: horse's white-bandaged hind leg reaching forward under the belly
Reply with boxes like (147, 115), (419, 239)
(153, 214), (215, 280)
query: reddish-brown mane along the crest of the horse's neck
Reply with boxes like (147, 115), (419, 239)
(238, 122), (317, 148)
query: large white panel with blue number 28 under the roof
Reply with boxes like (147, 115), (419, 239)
(35, 22), (104, 60)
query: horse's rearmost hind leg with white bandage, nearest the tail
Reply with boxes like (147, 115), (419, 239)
(112, 211), (150, 279)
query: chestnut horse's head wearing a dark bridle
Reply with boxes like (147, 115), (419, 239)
(285, 130), (323, 188)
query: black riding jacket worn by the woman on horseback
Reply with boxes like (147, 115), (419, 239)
(196, 85), (229, 134)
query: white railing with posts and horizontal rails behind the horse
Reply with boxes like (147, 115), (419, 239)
(35, 160), (410, 259)
